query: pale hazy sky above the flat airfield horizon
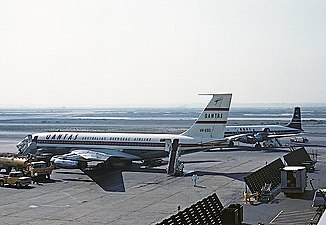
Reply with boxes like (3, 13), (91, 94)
(0, 0), (326, 107)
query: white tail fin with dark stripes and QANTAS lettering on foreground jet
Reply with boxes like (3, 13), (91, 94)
(182, 94), (232, 139)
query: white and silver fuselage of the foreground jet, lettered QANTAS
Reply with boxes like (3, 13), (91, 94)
(32, 132), (228, 160)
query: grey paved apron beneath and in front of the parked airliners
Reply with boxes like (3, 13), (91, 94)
(0, 129), (326, 225)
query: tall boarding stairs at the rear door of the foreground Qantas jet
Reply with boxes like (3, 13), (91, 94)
(165, 139), (183, 176)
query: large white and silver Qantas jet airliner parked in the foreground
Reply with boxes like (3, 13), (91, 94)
(17, 94), (232, 168)
